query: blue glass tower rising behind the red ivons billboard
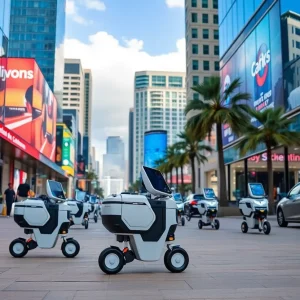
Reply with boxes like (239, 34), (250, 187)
(8, 0), (66, 121)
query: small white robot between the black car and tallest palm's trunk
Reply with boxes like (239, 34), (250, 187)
(197, 188), (220, 230)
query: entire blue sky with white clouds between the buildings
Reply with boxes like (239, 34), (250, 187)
(65, 0), (185, 159)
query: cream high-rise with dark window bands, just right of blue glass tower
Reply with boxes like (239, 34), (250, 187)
(63, 59), (84, 135)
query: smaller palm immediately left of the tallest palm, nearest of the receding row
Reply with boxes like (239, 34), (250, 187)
(174, 128), (213, 193)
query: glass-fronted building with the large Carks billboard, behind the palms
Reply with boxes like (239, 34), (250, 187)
(219, 0), (300, 201)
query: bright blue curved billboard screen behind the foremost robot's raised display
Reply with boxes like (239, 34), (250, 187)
(144, 130), (168, 168)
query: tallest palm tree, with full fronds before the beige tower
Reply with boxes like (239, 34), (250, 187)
(185, 76), (250, 206)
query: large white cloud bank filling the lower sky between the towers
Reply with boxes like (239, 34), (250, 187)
(65, 32), (185, 157)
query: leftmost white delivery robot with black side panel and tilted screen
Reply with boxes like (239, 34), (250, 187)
(9, 180), (80, 258)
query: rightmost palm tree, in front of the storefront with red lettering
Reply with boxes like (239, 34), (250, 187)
(236, 107), (300, 214)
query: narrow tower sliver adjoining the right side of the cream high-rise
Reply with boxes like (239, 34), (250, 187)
(83, 69), (93, 165)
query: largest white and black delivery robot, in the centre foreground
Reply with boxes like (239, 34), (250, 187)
(98, 166), (189, 274)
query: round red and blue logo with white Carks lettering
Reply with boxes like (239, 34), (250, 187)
(251, 44), (271, 86)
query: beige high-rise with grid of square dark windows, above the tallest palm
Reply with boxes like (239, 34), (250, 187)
(185, 0), (219, 100)
